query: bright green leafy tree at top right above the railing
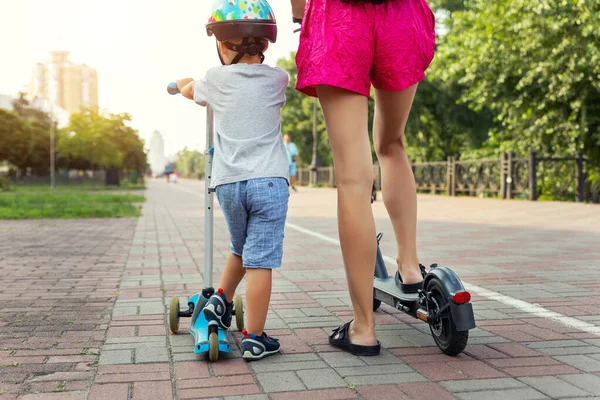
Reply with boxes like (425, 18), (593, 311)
(435, 0), (600, 160)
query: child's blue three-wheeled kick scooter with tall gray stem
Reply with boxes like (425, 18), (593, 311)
(167, 83), (244, 361)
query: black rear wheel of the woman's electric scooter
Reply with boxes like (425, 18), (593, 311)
(425, 278), (469, 356)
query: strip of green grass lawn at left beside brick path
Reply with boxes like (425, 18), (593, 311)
(0, 193), (145, 219)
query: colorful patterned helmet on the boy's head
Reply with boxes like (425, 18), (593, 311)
(206, 0), (277, 43)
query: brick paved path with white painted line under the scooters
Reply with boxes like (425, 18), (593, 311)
(0, 181), (600, 400)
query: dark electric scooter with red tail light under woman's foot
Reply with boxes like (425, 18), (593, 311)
(373, 233), (476, 356)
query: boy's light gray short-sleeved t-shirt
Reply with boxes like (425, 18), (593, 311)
(194, 64), (289, 188)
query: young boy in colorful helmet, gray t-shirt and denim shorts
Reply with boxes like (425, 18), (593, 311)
(172, 0), (289, 360)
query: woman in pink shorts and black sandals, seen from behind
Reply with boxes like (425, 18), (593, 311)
(291, 0), (435, 355)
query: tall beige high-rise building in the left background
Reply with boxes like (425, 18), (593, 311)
(28, 51), (98, 113)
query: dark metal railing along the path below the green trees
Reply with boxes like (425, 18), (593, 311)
(298, 152), (600, 203)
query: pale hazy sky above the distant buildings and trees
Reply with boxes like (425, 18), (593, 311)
(0, 0), (298, 155)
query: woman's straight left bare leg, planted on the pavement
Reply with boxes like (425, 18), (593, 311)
(317, 86), (377, 345)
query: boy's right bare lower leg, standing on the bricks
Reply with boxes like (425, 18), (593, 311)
(246, 268), (273, 336)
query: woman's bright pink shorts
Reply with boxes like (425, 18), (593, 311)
(296, 0), (435, 97)
